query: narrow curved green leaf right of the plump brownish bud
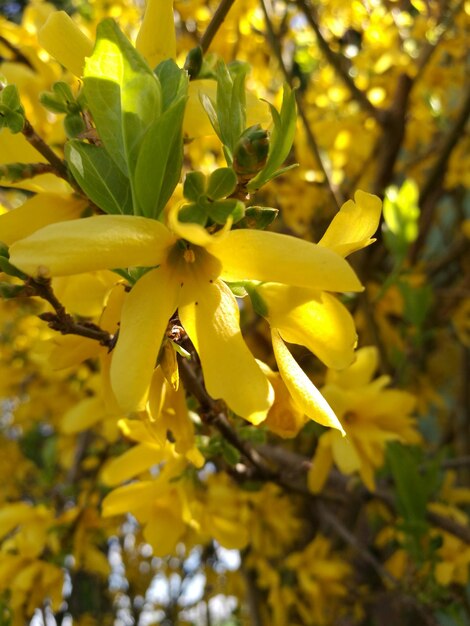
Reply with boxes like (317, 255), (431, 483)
(247, 85), (297, 191)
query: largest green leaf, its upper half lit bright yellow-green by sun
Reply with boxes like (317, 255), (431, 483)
(83, 19), (162, 181)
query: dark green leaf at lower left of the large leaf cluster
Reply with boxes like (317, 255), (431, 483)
(65, 139), (133, 215)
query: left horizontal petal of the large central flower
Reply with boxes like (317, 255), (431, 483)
(10, 215), (173, 276)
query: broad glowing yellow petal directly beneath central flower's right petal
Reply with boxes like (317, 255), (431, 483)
(257, 283), (357, 369)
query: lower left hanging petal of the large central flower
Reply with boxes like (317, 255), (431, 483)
(111, 268), (179, 411)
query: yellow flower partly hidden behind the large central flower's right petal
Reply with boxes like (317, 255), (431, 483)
(250, 191), (381, 434)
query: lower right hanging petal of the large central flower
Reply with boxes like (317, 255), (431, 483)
(179, 281), (273, 424)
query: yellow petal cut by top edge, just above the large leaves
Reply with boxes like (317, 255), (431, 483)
(135, 0), (176, 68)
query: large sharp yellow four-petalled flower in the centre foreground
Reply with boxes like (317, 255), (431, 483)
(10, 212), (361, 423)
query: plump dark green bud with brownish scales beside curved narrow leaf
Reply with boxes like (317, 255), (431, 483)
(233, 124), (269, 179)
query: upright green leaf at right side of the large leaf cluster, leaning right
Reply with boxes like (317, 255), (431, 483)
(135, 96), (186, 219)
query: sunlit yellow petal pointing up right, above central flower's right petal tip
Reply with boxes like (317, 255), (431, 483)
(319, 190), (382, 256)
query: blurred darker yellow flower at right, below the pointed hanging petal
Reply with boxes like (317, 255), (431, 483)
(308, 347), (420, 493)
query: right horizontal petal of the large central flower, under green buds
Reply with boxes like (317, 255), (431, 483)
(207, 230), (363, 291)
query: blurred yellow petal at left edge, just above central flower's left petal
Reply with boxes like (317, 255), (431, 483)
(0, 193), (88, 246)
